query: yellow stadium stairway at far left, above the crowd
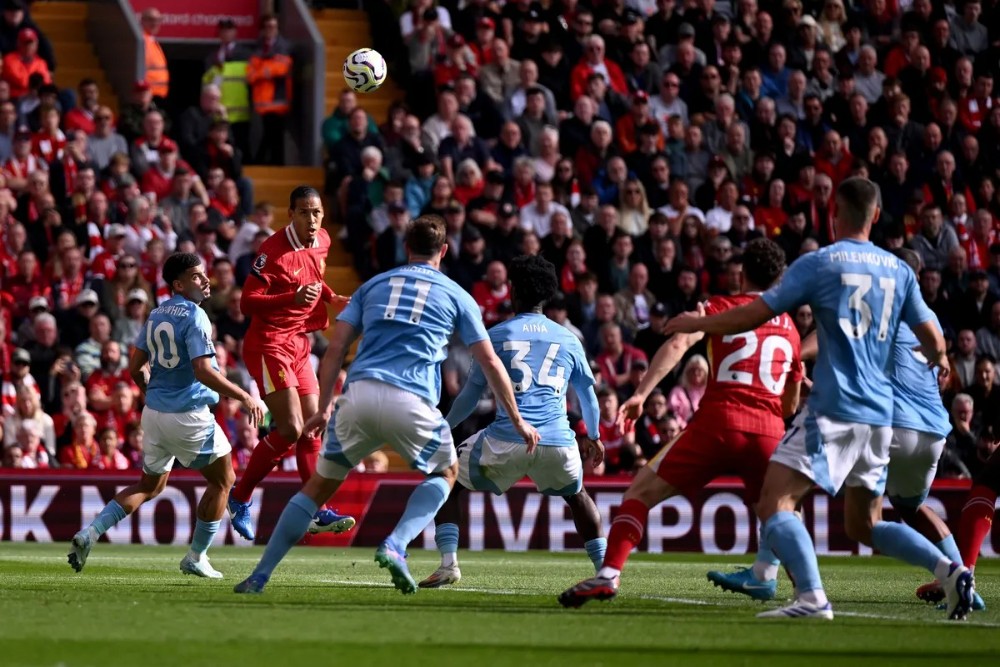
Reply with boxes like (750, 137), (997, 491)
(31, 2), (118, 114)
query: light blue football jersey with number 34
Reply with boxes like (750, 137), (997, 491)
(469, 313), (596, 447)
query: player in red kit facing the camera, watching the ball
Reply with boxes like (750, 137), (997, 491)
(229, 185), (354, 540)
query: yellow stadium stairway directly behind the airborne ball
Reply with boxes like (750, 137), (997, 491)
(313, 9), (404, 124)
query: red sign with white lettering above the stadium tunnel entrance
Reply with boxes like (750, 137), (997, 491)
(129, 0), (260, 40)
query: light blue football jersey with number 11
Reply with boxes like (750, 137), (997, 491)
(337, 264), (486, 405)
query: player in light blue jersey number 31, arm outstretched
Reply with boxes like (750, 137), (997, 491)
(667, 178), (973, 620)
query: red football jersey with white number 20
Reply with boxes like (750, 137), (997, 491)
(691, 294), (802, 438)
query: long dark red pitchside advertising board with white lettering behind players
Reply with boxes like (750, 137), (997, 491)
(0, 470), (1000, 556)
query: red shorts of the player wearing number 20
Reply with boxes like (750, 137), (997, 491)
(649, 428), (781, 505)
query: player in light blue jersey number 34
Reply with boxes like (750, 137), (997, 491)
(419, 256), (607, 588)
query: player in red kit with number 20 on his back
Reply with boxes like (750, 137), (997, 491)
(559, 239), (802, 607)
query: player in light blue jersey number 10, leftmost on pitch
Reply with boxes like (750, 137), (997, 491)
(69, 253), (264, 579)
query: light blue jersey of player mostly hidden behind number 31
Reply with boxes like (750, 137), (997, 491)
(889, 317), (951, 438)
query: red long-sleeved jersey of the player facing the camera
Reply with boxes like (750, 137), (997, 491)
(240, 225), (332, 349)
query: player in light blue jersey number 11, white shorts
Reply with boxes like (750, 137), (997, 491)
(234, 215), (538, 593)
